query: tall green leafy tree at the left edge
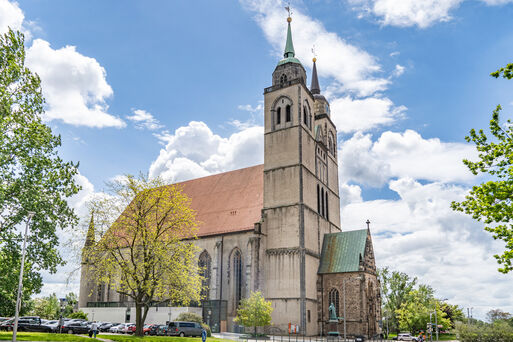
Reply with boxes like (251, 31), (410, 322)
(0, 30), (79, 316)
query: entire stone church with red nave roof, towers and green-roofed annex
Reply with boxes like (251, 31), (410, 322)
(79, 17), (381, 337)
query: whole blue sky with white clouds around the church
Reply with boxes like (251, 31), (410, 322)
(0, 0), (513, 317)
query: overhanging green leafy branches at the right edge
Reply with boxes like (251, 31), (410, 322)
(451, 64), (513, 273)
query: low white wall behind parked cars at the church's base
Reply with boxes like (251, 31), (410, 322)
(79, 307), (201, 324)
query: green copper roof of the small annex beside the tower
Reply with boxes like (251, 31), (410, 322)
(317, 229), (367, 274)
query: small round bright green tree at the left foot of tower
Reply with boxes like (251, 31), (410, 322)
(234, 291), (273, 336)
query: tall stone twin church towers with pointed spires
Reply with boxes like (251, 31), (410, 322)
(262, 17), (340, 335)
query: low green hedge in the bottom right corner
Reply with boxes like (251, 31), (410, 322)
(456, 323), (513, 342)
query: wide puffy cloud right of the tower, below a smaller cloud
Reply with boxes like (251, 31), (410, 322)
(339, 130), (477, 187)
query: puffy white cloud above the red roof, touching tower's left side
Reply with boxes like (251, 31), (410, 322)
(149, 121), (264, 182)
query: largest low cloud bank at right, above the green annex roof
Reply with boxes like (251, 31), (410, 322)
(341, 178), (513, 317)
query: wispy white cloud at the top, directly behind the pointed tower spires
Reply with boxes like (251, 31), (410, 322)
(241, 0), (389, 96)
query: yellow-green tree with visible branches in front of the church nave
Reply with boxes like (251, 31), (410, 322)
(83, 175), (201, 336)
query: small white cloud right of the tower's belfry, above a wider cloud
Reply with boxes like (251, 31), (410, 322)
(330, 96), (407, 133)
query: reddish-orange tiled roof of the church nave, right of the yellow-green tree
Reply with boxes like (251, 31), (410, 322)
(176, 165), (264, 237)
